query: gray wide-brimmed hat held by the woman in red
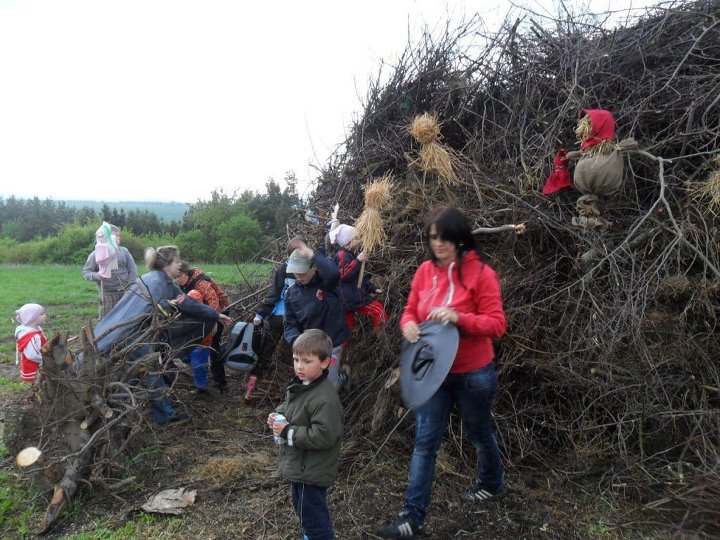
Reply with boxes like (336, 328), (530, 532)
(400, 321), (460, 409)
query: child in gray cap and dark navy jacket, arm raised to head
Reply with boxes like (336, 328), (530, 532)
(283, 240), (349, 390)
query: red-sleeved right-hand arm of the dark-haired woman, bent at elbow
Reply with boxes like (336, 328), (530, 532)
(455, 266), (507, 339)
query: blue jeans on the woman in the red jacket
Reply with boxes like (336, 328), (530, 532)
(405, 364), (504, 524)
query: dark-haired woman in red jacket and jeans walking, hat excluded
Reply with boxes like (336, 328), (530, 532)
(378, 207), (507, 538)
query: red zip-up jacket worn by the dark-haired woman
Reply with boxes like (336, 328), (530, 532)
(400, 251), (507, 373)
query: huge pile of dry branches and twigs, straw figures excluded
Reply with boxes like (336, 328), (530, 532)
(300, 0), (720, 526)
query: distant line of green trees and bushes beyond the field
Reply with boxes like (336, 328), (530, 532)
(0, 172), (301, 264)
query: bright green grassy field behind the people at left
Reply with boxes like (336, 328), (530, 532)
(0, 264), (272, 363)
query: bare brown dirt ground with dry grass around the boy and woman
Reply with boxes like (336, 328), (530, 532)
(4, 366), (669, 540)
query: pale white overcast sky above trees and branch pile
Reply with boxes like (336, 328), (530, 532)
(0, 0), (655, 202)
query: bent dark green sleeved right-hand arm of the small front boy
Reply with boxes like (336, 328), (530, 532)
(280, 400), (342, 450)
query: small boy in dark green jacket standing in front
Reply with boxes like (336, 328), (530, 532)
(267, 329), (343, 540)
